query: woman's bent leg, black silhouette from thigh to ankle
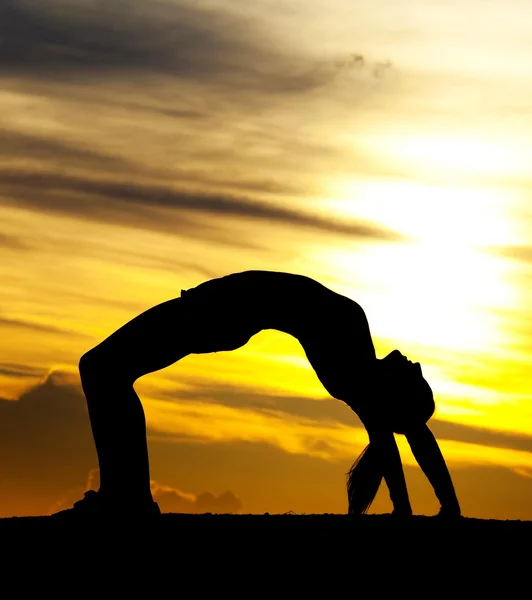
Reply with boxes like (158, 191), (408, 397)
(79, 298), (191, 503)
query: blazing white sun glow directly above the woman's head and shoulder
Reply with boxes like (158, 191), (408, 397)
(317, 181), (514, 351)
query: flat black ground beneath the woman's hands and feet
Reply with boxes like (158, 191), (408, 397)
(0, 513), (532, 588)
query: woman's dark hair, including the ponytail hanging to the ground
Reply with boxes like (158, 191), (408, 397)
(347, 378), (435, 515)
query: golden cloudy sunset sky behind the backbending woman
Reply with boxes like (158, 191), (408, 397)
(0, 0), (532, 519)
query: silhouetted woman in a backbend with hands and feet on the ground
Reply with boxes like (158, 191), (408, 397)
(56, 271), (460, 516)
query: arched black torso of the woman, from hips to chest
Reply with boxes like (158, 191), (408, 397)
(183, 271), (375, 397)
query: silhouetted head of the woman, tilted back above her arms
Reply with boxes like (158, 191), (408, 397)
(379, 350), (435, 433)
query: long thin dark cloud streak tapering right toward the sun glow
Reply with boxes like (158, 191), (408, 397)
(0, 168), (401, 241)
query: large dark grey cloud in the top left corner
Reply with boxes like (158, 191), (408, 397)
(0, 0), (330, 94)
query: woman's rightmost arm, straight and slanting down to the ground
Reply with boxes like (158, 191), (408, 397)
(406, 425), (461, 517)
